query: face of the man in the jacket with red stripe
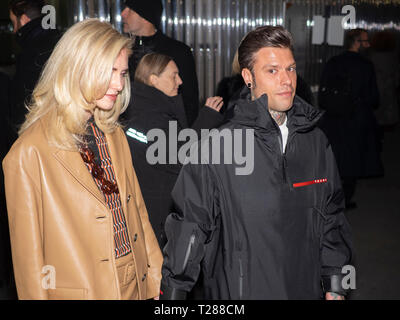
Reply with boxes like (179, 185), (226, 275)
(242, 47), (297, 112)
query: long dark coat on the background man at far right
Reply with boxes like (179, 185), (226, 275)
(319, 51), (383, 178)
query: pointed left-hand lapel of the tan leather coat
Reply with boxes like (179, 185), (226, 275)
(53, 149), (106, 205)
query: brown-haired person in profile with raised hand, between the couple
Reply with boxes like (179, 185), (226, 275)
(126, 53), (223, 248)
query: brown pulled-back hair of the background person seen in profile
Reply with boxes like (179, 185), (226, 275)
(135, 53), (172, 86)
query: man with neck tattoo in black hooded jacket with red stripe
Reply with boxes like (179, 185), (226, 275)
(161, 26), (352, 299)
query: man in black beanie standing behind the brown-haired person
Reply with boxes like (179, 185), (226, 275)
(121, 0), (199, 125)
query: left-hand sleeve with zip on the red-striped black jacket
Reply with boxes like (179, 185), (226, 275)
(161, 164), (219, 299)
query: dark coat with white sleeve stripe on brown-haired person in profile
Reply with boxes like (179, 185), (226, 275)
(125, 81), (223, 248)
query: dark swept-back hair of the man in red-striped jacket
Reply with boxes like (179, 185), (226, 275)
(239, 26), (293, 71)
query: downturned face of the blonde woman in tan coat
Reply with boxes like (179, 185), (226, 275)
(96, 49), (128, 111)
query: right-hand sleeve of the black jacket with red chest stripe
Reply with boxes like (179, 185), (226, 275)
(321, 141), (353, 295)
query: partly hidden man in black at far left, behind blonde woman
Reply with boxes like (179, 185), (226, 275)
(9, 0), (60, 142)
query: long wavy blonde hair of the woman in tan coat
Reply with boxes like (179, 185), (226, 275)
(19, 19), (132, 150)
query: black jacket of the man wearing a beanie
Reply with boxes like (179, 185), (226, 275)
(129, 31), (199, 125)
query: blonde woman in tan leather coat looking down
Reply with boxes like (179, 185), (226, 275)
(3, 19), (162, 299)
